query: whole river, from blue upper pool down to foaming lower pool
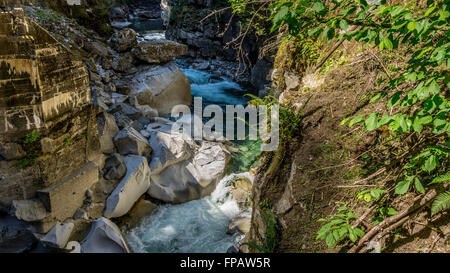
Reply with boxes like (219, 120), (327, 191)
(125, 57), (259, 253)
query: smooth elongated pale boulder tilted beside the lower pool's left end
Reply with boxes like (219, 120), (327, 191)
(104, 156), (150, 218)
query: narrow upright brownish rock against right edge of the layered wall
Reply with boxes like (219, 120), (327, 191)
(98, 110), (119, 154)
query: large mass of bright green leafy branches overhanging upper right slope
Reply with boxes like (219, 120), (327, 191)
(272, 0), (450, 217)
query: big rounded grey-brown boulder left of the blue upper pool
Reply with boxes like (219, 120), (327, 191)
(130, 63), (192, 115)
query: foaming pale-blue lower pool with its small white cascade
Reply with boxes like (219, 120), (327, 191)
(125, 173), (252, 253)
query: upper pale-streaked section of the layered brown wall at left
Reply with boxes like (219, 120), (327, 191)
(0, 9), (91, 135)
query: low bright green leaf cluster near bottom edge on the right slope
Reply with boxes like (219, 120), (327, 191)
(316, 206), (365, 247)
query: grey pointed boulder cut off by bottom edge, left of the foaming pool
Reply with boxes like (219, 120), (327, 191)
(81, 217), (130, 253)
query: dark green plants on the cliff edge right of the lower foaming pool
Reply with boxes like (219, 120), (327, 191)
(243, 209), (279, 253)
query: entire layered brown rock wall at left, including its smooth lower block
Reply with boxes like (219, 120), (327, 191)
(0, 9), (100, 230)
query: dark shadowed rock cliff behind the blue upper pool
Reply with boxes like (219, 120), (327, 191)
(161, 0), (273, 91)
